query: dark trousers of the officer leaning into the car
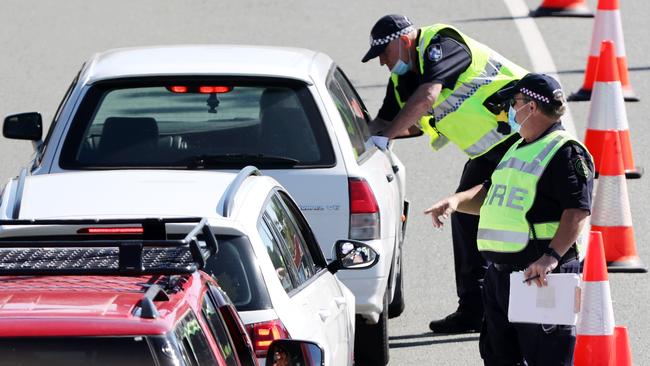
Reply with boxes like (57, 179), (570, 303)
(451, 134), (519, 318)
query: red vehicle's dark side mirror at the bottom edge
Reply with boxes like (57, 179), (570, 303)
(266, 339), (325, 366)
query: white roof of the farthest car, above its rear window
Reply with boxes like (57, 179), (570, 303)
(80, 45), (332, 84)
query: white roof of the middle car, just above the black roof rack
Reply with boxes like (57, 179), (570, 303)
(19, 170), (268, 229)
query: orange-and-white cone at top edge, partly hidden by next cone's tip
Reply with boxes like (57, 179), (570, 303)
(568, 0), (639, 102)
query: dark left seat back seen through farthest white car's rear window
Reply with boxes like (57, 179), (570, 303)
(98, 117), (158, 163)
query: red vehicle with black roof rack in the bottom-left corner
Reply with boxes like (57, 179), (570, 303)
(0, 218), (322, 366)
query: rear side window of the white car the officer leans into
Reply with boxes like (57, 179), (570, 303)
(327, 69), (370, 157)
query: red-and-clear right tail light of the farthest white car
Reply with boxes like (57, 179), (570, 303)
(348, 178), (380, 240)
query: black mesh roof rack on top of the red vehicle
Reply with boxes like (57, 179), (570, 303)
(0, 217), (218, 275)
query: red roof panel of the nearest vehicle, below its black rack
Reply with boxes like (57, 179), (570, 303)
(0, 272), (207, 337)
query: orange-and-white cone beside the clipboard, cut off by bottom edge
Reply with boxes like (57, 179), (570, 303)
(573, 231), (616, 366)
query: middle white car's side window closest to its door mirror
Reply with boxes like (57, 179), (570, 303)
(265, 195), (316, 286)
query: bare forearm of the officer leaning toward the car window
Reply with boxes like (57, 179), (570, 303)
(384, 83), (442, 139)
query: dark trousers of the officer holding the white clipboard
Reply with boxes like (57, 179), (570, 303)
(479, 259), (580, 366)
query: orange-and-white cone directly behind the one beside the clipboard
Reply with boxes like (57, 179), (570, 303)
(587, 130), (648, 272)
